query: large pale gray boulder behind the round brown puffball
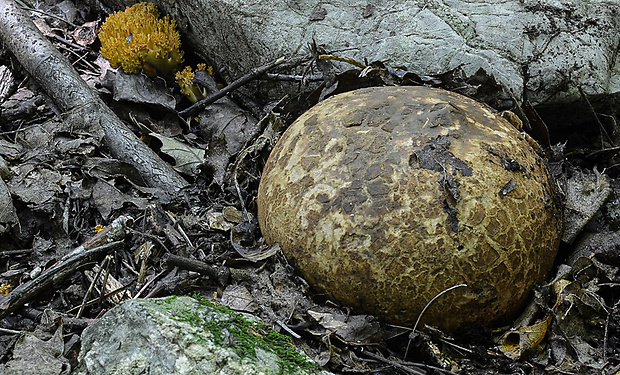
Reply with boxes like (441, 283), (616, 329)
(99, 0), (620, 105)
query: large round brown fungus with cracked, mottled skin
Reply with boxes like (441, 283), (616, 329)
(258, 87), (562, 332)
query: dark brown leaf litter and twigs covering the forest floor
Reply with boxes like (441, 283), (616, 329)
(0, 2), (620, 374)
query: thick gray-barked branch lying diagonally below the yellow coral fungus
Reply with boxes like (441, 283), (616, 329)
(0, 0), (187, 193)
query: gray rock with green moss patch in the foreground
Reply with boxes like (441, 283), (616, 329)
(77, 297), (329, 375)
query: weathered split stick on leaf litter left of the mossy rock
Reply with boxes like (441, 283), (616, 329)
(0, 241), (123, 319)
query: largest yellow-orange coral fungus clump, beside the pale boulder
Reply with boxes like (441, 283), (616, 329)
(99, 3), (183, 77)
